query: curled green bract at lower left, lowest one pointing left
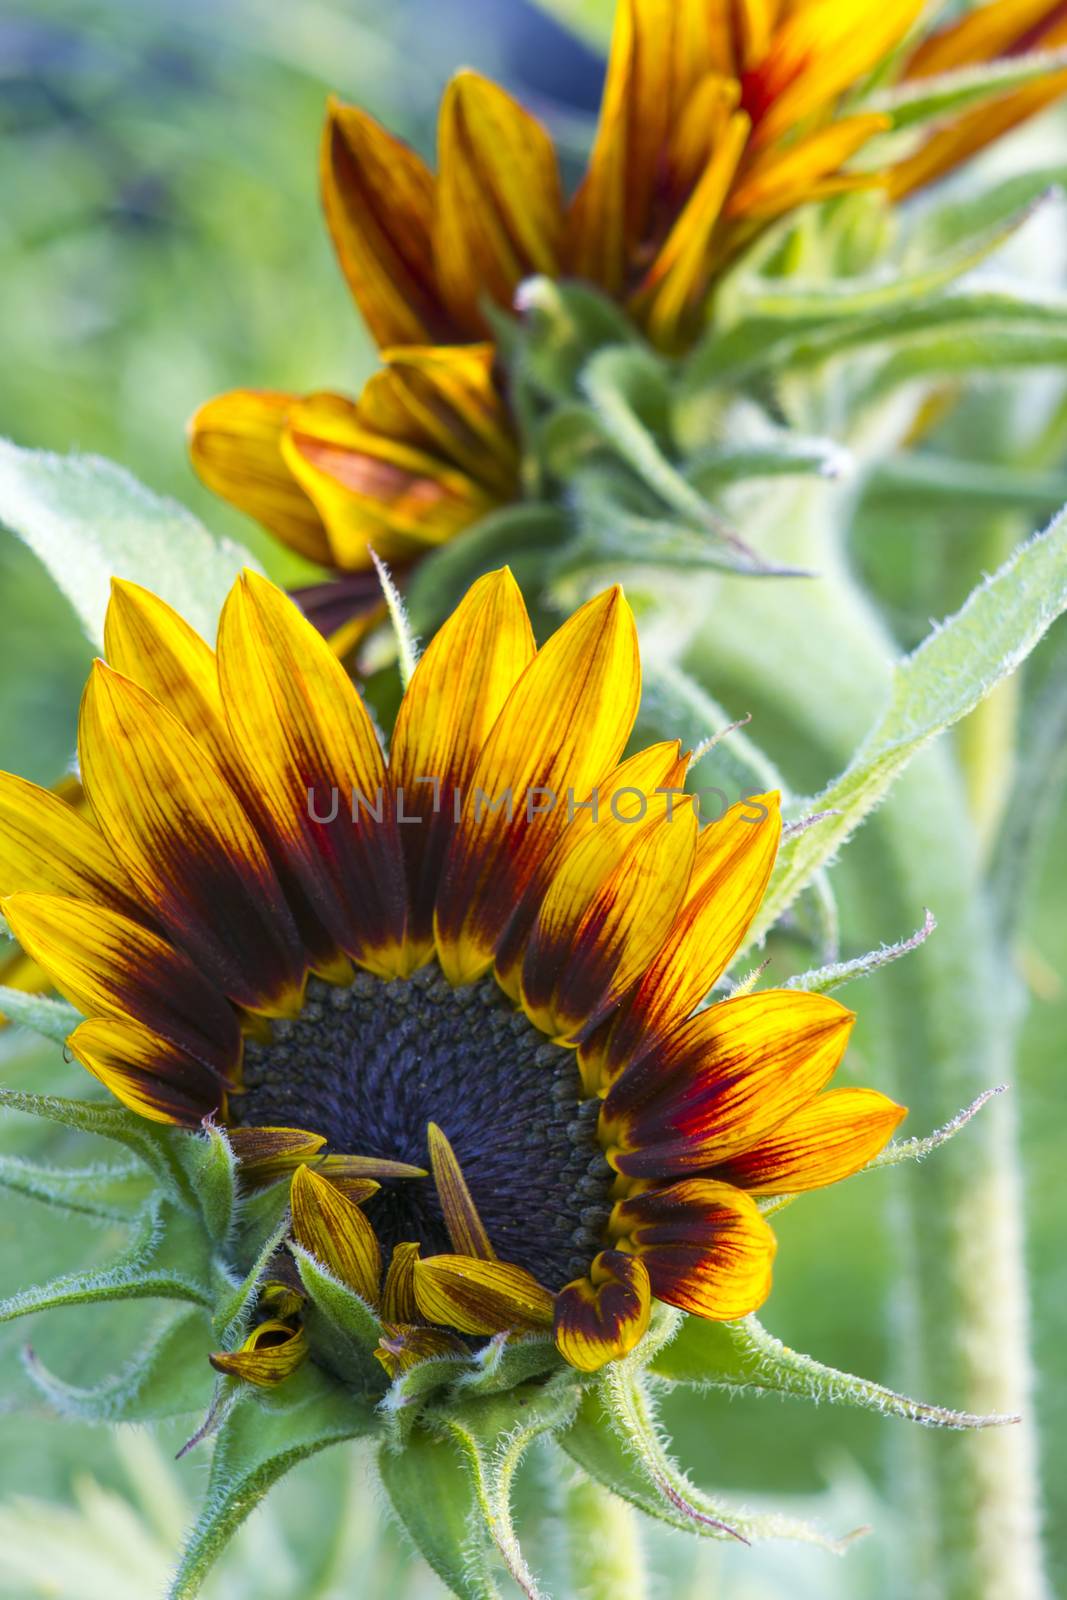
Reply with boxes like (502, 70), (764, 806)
(26, 1310), (211, 1422)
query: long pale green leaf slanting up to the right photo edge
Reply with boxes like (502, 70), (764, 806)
(749, 514), (1067, 942)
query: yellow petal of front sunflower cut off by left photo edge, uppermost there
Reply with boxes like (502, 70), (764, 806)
(0, 773), (139, 915)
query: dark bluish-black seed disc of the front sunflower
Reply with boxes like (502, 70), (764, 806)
(234, 963), (613, 1290)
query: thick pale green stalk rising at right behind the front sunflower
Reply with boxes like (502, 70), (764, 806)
(686, 483), (1048, 1600)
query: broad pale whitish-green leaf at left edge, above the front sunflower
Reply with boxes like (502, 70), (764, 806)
(0, 440), (258, 648)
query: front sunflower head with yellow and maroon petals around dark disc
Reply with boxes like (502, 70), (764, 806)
(0, 571), (902, 1382)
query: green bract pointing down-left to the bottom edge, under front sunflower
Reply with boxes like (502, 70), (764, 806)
(168, 1363), (374, 1600)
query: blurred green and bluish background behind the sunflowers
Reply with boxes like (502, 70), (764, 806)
(0, 0), (1067, 1600)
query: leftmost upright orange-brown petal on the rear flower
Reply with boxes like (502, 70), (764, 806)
(322, 99), (451, 344)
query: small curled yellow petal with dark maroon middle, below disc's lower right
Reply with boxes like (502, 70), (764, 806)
(555, 1250), (651, 1373)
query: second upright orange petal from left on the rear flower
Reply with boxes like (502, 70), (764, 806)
(434, 70), (563, 334)
